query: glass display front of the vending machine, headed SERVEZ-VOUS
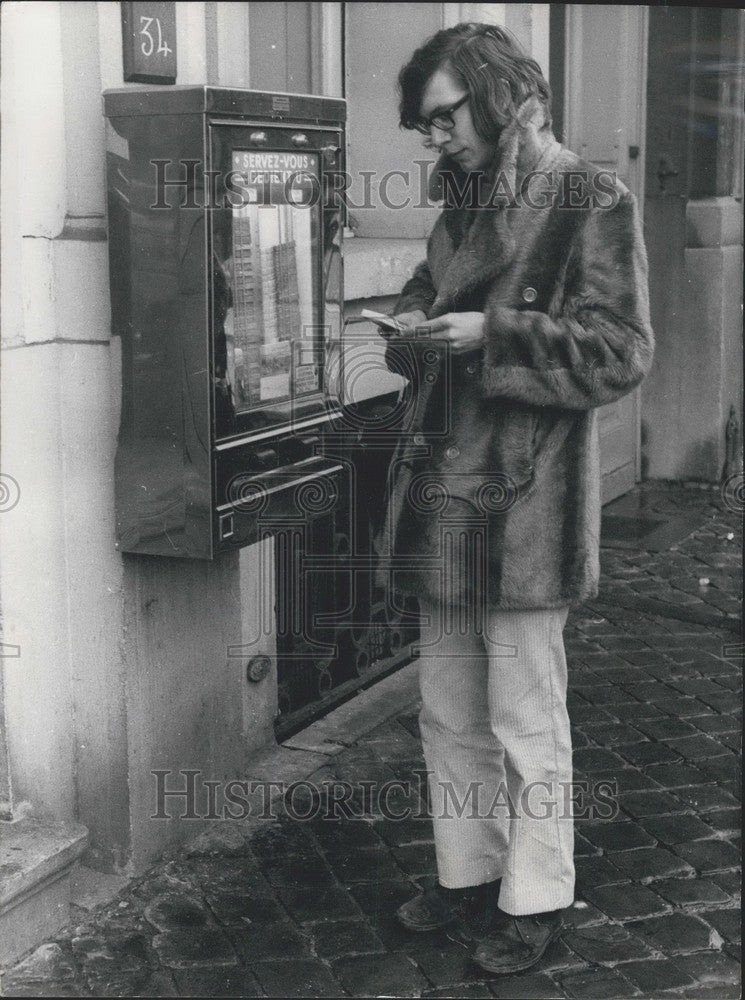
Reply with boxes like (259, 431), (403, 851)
(206, 125), (325, 439)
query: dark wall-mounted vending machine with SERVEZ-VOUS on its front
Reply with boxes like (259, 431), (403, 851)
(104, 87), (345, 559)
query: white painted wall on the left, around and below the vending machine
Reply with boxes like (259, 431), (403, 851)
(0, 2), (276, 868)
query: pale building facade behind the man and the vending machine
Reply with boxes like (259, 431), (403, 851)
(0, 2), (744, 960)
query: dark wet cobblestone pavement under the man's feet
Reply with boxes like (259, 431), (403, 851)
(4, 484), (742, 1000)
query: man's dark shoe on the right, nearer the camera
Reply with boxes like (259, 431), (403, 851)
(473, 910), (565, 974)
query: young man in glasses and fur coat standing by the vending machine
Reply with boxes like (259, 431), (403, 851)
(376, 24), (653, 973)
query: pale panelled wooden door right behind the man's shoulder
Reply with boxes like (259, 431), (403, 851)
(564, 4), (647, 503)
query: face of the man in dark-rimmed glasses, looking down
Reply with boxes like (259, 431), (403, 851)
(419, 68), (494, 171)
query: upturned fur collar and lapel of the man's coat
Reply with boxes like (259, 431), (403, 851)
(430, 97), (560, 315)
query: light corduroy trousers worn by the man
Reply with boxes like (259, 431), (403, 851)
(419, 598), (574, 915)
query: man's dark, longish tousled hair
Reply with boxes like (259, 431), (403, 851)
(398, 22), (551, 142)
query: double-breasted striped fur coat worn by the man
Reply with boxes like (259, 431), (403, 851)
(375, 98), (654, 610)
